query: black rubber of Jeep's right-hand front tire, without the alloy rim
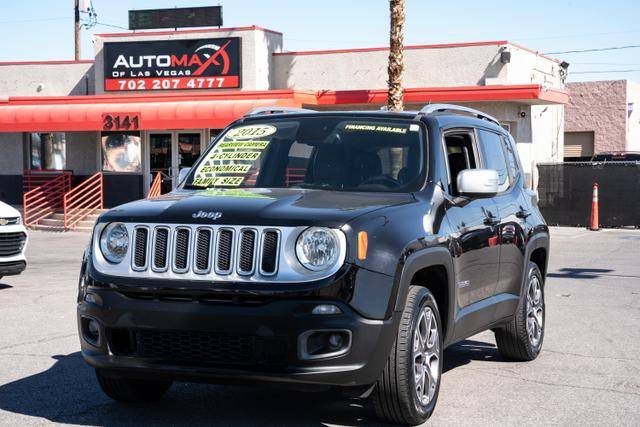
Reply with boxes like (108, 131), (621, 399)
(371, 286), (442, 425)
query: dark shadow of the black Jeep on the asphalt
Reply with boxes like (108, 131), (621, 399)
(0, 341), (499, 427)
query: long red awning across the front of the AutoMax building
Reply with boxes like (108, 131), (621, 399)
(0, 84), (569, 132)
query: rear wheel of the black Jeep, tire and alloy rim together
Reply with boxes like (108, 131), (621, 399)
(494, 262), (545, 361)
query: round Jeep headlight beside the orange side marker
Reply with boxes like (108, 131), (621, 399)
(296, 227), (340, 271)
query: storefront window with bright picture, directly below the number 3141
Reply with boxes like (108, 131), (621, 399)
(100, 132), (142, 173)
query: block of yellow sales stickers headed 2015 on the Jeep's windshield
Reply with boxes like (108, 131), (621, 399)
(192, 125), (277, 187)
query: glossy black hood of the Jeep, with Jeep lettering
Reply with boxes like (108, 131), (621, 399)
(100, 188), (415, 227)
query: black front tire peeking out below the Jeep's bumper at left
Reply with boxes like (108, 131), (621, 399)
(96, 370), (172, 403)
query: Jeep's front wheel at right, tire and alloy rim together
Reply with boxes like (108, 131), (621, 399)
(372, 286), (442, 425)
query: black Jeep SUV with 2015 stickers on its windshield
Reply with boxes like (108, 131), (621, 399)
(77, 105), (549, 424)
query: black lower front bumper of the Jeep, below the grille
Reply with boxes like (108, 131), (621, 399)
(77, 276), (397, 386)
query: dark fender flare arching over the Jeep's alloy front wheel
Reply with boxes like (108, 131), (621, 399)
(388, 246), (456, 341)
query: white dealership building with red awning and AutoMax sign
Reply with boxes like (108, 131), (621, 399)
(0, 26), (569, 211)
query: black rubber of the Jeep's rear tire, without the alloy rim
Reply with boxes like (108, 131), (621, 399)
(494, 262), (546, 362)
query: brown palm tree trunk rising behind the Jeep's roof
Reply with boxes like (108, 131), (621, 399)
(387, 0), (404, 176)
